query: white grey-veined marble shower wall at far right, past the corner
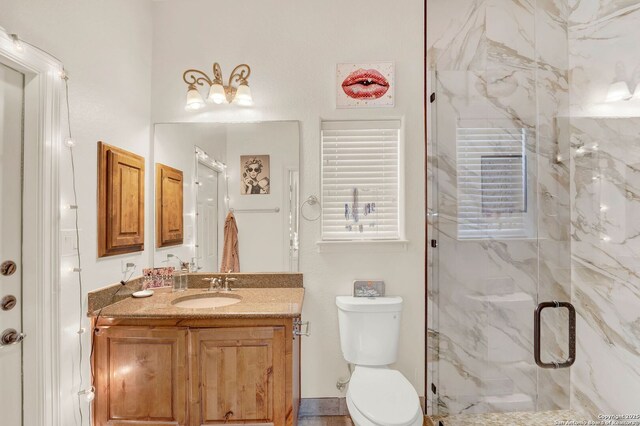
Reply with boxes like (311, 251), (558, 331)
(569, 0), (640, 417)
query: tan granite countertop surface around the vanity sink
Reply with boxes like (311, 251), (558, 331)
(89, 287), (304, 319)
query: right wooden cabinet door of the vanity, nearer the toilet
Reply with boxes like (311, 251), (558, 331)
(191, 327), (286, 425)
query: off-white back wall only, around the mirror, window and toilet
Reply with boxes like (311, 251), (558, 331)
(152, 0), (425, 398)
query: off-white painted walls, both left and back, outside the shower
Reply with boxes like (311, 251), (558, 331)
(0, 0), (425, 414)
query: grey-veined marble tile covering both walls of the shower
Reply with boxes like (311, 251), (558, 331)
(427, 0), (640, 416)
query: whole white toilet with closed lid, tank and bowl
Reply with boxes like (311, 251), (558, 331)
(336, 296), (424, 426)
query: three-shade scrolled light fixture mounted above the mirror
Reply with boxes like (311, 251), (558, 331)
(182, 62), (253, 111)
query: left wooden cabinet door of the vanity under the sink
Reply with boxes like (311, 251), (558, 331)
(93, 327), (188, 426)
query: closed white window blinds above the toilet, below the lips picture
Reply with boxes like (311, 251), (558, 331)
(321, 120), (400, 241)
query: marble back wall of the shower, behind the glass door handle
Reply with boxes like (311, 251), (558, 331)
(427, 0), (571, 414)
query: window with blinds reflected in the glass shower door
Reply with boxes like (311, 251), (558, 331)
(457, 128), (534, 239)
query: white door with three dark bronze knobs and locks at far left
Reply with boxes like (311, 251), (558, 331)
(0, 64), (24, 426)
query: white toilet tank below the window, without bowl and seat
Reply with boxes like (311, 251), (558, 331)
(336, 296), (402, 366)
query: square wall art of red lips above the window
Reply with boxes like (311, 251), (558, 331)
(336, 62), (395, 108)
